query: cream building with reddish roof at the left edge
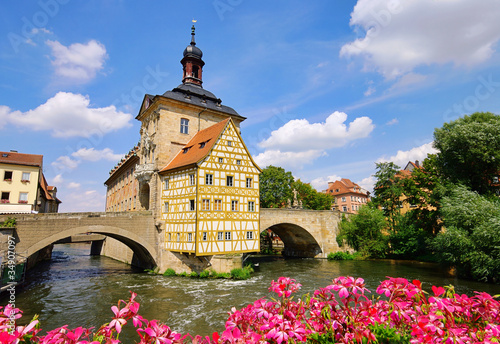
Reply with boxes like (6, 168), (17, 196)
(0, 151), (61, 214)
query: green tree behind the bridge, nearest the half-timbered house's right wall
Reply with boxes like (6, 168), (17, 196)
(259, 166), (293, 208)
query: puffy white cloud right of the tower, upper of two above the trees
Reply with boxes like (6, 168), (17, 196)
(259, 111), (375, 152)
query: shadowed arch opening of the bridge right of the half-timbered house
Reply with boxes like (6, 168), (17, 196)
(265, 223), (323, 258)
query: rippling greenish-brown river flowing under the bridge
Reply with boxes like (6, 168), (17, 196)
(0, 244), (500, 343)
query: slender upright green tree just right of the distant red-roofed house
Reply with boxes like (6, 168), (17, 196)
(372, 162), (404, 230)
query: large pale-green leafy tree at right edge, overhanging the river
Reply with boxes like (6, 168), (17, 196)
(432, 186), (500, 282)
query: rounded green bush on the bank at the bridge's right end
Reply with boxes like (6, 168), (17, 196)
(337, 202), (388, 258)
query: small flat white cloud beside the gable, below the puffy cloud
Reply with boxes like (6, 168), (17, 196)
(253, 150), (326, 169)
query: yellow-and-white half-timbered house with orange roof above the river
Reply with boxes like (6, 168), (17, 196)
(159, 118), (261, 256)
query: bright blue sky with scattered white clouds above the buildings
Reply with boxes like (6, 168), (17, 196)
(0, 0), (500, 212)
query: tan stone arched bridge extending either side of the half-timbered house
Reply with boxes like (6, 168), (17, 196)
(0, 209), (341, 271)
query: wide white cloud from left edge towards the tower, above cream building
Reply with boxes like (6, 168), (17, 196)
(0, 92), (132, 137)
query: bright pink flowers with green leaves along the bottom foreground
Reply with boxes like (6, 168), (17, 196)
(0, 277), (500, 344)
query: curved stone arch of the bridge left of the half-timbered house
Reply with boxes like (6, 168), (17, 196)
(26, 225), (157, 268)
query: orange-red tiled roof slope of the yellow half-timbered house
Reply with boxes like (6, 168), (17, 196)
(160, 118), (231, 173)
